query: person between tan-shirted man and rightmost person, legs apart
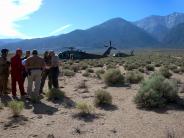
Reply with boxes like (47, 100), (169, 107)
(40, 51), (52, 94)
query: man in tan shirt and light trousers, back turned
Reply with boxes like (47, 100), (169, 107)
(25, 50), (45, 96)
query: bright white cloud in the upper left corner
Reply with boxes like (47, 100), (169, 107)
(0, 0), (43, 38)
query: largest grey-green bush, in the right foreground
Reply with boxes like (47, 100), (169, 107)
(134, 74), (178, 108)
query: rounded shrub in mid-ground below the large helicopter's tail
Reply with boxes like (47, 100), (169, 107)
(104, 69), (124, 86)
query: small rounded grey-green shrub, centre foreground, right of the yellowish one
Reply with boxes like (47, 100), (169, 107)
(94, 90), (112, 106)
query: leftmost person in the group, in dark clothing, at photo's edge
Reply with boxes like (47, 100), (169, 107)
(0, 49), (10, 96)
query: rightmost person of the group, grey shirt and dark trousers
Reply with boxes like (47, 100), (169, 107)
(50, 51), (59, 88)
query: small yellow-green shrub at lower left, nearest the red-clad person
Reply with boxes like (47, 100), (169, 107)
(8, 101), (24, 117)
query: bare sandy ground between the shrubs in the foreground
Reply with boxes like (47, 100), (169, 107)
(0, 66), (184, 138)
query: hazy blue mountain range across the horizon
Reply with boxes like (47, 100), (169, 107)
(0, 13), (184, 51)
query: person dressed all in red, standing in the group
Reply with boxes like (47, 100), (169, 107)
(11, 49), (26, 97)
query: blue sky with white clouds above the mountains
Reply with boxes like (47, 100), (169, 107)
(0, 0), (184, 39)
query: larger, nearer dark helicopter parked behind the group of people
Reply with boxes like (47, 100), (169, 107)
(59, 41), (133, 60)
